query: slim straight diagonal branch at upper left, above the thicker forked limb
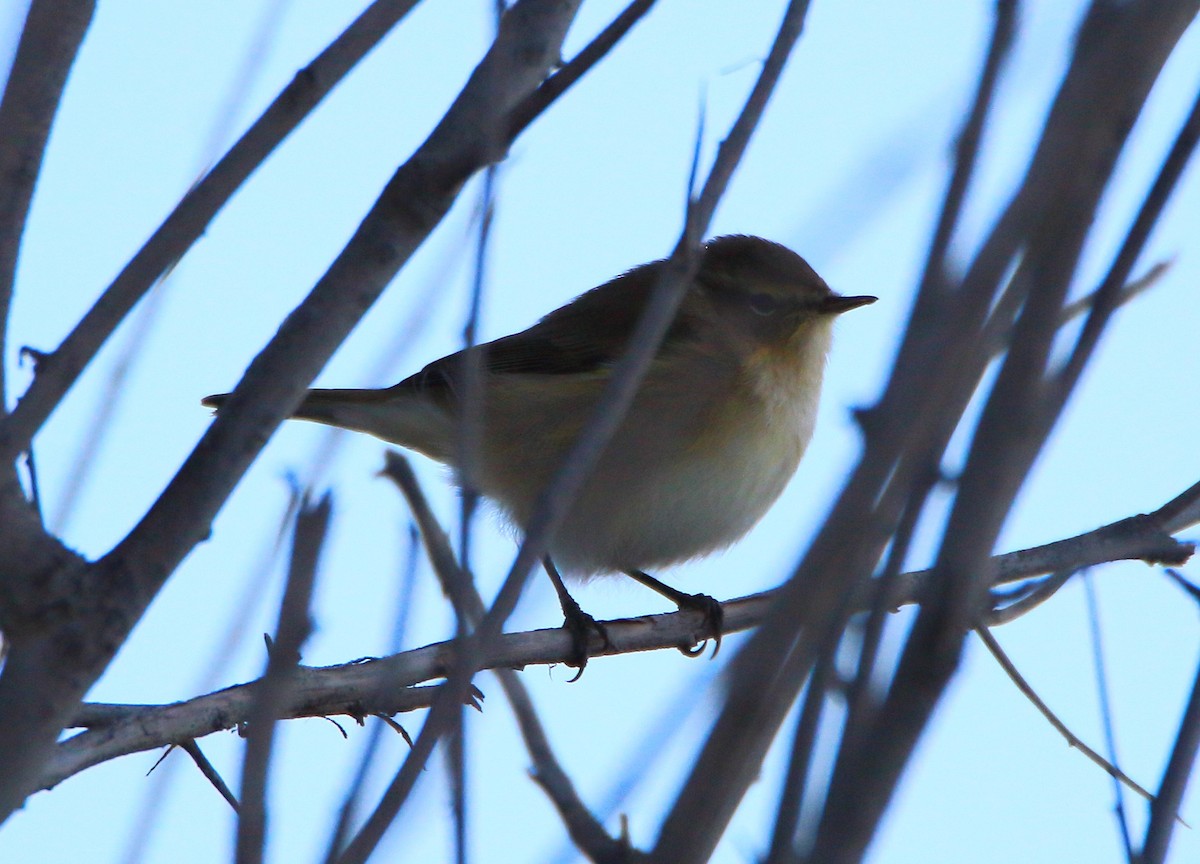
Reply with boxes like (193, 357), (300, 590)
(0, 0), (416, 462)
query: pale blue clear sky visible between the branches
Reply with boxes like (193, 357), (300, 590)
(0, 0), (1200, 864)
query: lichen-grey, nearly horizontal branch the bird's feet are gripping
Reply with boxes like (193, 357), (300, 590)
(38, 484), (1200, 788)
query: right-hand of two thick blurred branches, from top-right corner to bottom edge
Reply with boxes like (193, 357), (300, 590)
(814, 0), (1196, 862)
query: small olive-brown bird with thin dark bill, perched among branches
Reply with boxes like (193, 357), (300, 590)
(204, 235), (876, 670)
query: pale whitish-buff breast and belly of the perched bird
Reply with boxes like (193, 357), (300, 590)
(540, 326), (828, 575)
